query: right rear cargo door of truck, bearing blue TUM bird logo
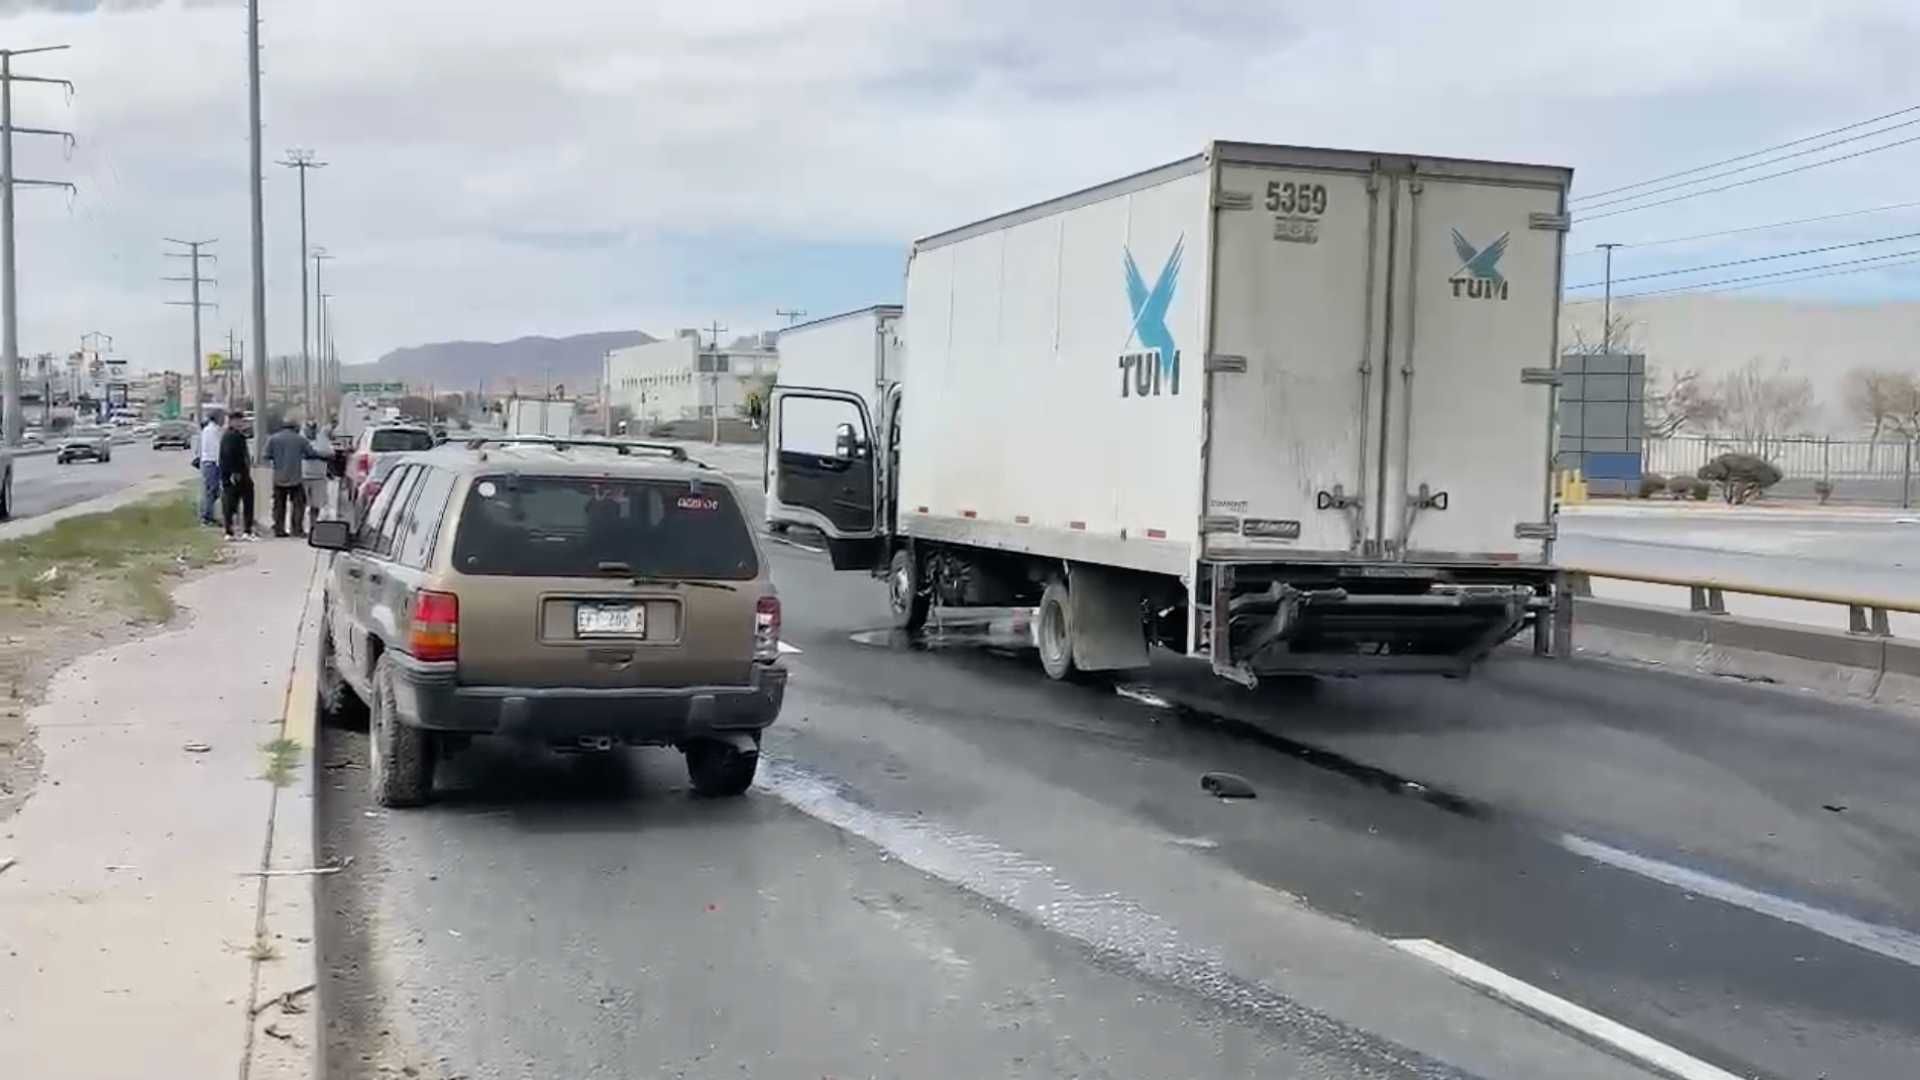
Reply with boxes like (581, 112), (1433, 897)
(1369, 161), (1569, 561)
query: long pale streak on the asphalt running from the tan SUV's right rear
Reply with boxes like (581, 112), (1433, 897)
(756, 755), (1469, 1078)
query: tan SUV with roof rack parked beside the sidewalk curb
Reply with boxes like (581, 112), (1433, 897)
(307, 440), (787, 807)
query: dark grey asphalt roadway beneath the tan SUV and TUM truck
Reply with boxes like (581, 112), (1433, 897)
(319, 484), (1920, 1078)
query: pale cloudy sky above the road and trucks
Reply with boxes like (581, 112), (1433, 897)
(0, 0), (1920, 365)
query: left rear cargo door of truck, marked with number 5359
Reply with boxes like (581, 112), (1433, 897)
(1202, 161), (1386, 559)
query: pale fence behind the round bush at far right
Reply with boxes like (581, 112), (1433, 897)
(1645, 434), (1920, 505)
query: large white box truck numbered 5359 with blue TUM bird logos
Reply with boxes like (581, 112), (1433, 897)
(768, 142), (1572, 684)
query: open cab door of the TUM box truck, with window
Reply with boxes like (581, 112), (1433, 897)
(766, 384), (887, 571)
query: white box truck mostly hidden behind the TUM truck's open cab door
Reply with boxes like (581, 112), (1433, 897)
(766, 304), (906, 532)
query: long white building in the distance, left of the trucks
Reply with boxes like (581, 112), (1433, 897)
(607, 331), (780, 425)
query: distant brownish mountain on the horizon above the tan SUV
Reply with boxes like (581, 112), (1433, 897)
(340, 331), (657, 394)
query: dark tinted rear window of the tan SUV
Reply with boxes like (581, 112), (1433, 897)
(453, 475), (760, 580)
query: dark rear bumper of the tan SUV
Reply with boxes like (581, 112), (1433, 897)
(388, 651), (787, 746)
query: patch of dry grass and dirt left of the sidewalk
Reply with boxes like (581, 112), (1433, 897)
(0, 488), (232, 821)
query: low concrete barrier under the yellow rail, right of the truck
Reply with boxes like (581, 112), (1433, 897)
(1574, 598), (1920, 709)
